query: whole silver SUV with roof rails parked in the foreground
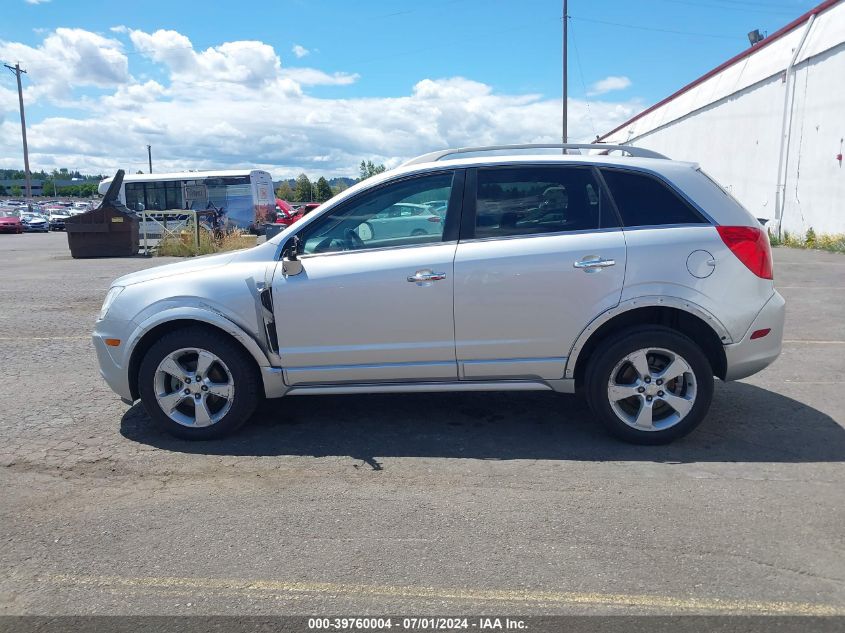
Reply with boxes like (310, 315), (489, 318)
(94, 145), (784, 444)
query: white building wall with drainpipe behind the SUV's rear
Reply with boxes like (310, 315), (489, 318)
(602, 2), (845, 234)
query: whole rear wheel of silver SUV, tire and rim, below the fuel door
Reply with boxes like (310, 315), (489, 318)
(585, 326), (713, 444)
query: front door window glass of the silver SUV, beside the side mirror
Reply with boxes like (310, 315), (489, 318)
(301, 172), (452, 254)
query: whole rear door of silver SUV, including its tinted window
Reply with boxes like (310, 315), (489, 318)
(455, 164), (625, 380)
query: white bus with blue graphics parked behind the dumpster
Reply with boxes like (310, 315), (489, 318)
(98, 169), (276, 233)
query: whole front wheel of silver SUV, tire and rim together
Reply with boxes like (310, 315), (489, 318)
(138, 327), (261, 440)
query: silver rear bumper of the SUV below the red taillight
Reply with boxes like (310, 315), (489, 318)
(725, 292), (786, 380)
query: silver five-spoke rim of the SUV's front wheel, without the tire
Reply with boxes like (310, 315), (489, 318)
(154, 347), (235, 428)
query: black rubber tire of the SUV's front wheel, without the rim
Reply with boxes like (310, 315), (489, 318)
(138, 326), (263, 440)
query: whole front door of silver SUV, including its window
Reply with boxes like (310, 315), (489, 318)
(273, 169), (464, 385)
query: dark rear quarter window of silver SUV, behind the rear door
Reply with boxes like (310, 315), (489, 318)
(602, 169), (707, 226)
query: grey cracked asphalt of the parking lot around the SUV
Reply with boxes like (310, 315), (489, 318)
(0, 233), (845, 615)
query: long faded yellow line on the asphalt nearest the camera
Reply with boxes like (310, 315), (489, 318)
(44, 574), (845, 616)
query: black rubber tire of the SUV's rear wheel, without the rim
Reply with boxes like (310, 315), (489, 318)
(584, 325), (713, 444)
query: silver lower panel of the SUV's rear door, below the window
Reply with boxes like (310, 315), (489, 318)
(455, 230), (625, 379)
